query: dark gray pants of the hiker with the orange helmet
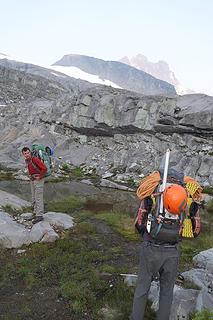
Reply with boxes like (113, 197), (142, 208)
(130, 242), (179, 320)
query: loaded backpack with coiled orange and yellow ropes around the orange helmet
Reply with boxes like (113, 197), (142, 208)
(135, 175), (202, 242)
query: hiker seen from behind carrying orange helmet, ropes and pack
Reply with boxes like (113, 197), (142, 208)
(130, 150), (202, 320)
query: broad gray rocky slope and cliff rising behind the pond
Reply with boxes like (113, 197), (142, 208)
(0, 62), (213, 185)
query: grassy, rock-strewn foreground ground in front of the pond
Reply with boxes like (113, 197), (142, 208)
(0, 191), (213, 320)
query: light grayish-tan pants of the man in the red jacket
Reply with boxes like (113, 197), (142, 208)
(30, 179), (44, 216)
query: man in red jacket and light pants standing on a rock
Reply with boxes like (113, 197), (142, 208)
(22, 147), (47, 223)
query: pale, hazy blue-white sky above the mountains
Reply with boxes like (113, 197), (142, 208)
(0, 0), (213, 95)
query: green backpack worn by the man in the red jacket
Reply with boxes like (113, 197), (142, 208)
(31, 144), (52, 177)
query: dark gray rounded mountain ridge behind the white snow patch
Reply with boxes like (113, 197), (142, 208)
(53, 54), (176, 95)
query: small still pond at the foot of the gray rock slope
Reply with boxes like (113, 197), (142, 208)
(0, 180), (139, 216)
